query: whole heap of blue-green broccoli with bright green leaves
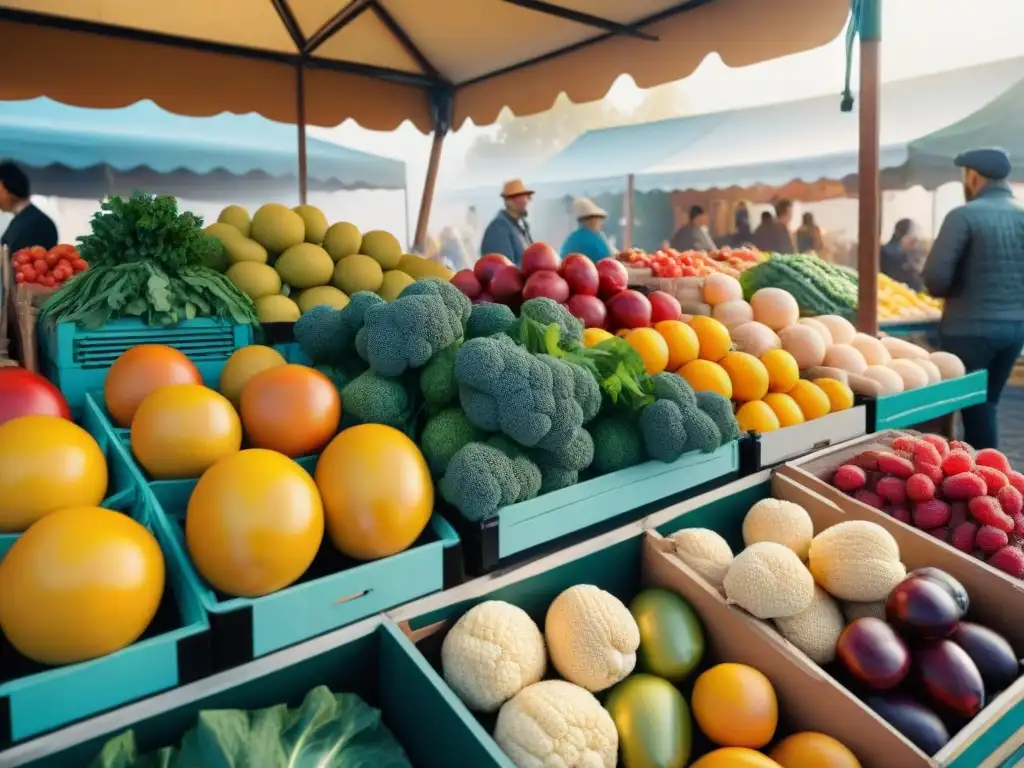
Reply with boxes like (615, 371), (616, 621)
(295, 279), (738, 521)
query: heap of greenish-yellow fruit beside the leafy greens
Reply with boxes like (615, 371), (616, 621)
(204, 203), (452, 323)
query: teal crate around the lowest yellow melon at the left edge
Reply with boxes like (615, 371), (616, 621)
(0, 487), (212, 745)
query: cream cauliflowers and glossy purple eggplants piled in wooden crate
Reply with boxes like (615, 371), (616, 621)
(672, 499), (1020, 755)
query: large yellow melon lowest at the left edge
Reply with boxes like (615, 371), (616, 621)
(0, 507), (165, 666)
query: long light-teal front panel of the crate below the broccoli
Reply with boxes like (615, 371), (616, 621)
(450, 441), (739, 573)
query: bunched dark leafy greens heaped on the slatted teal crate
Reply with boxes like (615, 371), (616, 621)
(41, 193), (256, 328)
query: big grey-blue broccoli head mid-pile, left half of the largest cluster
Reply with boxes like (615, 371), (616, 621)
(455, 336), (557, 447)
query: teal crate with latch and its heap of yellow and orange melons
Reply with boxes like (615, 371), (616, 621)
(78, 346), (461, 668)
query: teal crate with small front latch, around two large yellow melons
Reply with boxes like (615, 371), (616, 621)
(147, 468), (462, 669)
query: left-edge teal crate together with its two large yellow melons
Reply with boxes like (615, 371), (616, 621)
(0, 385), (211, 748)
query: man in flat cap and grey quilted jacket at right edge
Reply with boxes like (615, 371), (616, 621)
(922, 148), (1024, 449)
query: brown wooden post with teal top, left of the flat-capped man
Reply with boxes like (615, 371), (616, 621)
(857, 0), (882, 336)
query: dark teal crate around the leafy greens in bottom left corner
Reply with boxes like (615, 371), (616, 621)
(0, 616), (497, 768)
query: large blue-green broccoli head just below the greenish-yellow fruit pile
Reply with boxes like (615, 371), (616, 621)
(356, 294), (462, 376)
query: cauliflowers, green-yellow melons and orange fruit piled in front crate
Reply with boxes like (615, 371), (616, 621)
(441, 584), (860, 768)
